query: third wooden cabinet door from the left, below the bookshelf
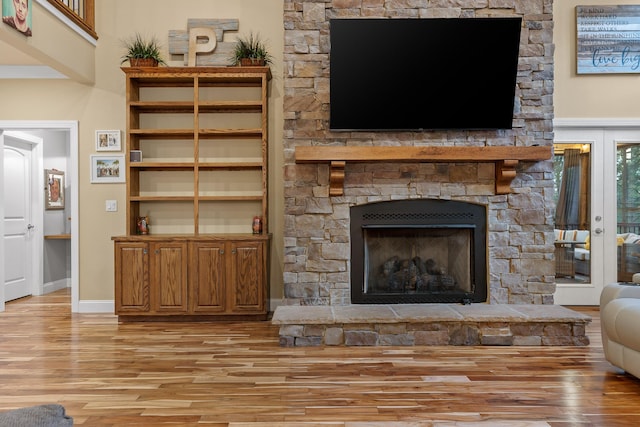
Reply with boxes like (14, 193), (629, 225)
(189, 242), (226, 314)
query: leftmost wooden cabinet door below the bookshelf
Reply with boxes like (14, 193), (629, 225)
(115, 242), (151, 314)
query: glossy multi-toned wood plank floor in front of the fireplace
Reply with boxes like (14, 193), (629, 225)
(0, 290), (640, 427)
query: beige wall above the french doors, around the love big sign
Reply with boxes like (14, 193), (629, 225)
(553, 0), (640, 119)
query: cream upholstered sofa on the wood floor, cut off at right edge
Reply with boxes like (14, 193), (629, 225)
(600, 283), (640, 378)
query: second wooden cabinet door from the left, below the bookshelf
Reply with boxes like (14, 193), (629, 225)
(150, 241), (187, 314)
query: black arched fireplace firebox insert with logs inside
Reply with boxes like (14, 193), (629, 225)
(350, 199), (488, 304)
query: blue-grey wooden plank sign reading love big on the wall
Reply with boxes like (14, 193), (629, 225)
(576, 5), (640, 74)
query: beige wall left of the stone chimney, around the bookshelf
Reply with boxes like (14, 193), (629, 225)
(0, 0), (284, 302)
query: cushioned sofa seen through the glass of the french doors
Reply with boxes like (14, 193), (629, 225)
(555, 229), (640, 282)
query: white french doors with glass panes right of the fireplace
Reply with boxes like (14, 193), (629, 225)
(554, 122), (640, 305)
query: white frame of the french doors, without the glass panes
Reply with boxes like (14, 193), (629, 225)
(554, 118), (640, 305)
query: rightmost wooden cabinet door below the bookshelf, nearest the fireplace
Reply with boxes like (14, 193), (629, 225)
(229, 241), (266, 313)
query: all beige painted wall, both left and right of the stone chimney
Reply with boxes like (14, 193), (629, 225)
(0, 0), (640, 308)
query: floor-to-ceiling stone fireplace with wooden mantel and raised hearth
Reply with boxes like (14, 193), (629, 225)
(272, 0), (590, 346)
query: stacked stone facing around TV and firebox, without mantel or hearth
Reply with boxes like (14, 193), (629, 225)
(283, 0), (555, 308)
